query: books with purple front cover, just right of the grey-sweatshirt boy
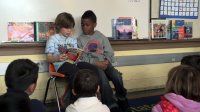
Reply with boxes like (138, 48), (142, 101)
(111, 17), (138, 40)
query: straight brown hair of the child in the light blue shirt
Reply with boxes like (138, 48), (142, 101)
(55, 12), (75, 33)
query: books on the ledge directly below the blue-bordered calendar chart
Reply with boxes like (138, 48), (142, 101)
(150, 19), (193, 40)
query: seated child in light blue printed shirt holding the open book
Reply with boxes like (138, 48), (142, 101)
(45, 12), (99, 107)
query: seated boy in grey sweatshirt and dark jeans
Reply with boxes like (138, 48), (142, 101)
(78, 10), (129, 112)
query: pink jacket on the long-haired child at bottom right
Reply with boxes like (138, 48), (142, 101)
(152, 93), (200, 112)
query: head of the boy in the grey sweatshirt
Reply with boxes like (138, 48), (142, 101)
(81, 10), (97, 35)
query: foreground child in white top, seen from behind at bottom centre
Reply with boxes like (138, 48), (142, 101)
(65, 69), (110, 112)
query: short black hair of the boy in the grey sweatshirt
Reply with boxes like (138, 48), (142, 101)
(81, 10), (97, 23)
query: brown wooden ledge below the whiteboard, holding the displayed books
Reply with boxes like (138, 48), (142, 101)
(0, 39), (200, 56)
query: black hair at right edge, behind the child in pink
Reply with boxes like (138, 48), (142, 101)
(181, 55), (200, 71)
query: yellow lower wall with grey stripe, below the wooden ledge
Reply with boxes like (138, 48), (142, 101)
(0, 44), (200, 100)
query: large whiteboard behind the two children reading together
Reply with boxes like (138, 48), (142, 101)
(0, 0), (149, 41)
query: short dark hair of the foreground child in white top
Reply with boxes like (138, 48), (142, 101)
(73, 69), (99, 97)
